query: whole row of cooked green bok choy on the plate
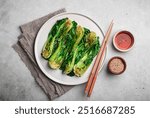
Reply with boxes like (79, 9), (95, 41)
(41, 18), (100, 77)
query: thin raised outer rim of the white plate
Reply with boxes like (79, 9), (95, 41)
(33, 12), (107, 85)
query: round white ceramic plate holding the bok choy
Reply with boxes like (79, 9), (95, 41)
(34, 13), (106, 85)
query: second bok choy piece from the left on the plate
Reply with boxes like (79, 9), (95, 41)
(49, 20), (77, 69)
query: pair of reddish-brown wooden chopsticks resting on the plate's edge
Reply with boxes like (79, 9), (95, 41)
(85, 20), (113, 97)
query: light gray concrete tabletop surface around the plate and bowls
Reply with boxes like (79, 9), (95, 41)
(0, 0), (150, 100)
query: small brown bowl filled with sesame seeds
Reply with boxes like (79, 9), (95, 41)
(108, 57), (126, 75)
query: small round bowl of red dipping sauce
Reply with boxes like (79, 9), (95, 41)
(113, 31), (134, 52)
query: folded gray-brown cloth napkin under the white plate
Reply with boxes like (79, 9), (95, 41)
(13, 8), (73, 100)
